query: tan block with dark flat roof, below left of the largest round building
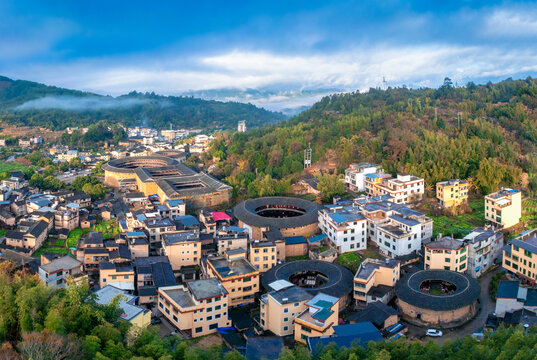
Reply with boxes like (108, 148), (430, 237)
(206, 253), (260, 306)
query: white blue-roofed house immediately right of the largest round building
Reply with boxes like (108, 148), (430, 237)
(319, 205), (367, 253)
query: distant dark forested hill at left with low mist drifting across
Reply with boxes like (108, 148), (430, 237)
(0, 76), (285, 130)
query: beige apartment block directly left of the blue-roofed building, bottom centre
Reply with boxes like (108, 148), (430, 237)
(259, 280), (313, 336)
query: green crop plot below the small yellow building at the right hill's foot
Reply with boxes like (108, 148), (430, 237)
(427, 199), (485, 238)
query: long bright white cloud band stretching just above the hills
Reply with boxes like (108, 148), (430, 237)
(6, 44), (537, 109)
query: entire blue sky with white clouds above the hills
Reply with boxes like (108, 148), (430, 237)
(0, 0), (537, 109)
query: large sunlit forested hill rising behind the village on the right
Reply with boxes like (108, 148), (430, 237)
(204, 78), (537, 198)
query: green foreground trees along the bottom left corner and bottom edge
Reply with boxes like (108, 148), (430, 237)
(0, 262), (537, 360)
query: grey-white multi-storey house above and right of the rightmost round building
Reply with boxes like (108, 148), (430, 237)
(461, 227), (503, 278)
